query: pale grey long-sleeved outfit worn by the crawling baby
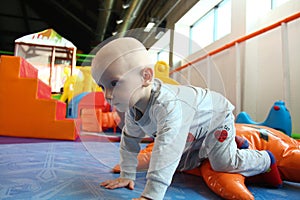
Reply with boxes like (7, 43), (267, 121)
(120, 79), (270, 200)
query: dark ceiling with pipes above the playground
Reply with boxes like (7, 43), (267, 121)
(0, 0), (193, 53)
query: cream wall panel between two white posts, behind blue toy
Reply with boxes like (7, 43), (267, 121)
(242, 28), (285, 121)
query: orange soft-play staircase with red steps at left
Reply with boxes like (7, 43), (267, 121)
(0, 56), (77, 140)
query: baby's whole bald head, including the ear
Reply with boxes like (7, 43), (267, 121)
(92, 37), (154, 111)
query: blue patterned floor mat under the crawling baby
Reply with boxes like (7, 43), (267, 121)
(0, 136), (300, 200)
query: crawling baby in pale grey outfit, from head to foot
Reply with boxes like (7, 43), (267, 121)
(92, 37), (282, 200)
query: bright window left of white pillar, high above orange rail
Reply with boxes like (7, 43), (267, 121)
(190, 0), (231, 54)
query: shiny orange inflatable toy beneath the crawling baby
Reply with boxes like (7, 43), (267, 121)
(113, 124), (300, 199)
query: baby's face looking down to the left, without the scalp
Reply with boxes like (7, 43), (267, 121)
(99, 59), (143, 112)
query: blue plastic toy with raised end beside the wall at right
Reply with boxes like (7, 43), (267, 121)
(236, 101), (292, 136)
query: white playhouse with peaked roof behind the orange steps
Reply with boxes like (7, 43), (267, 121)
(14, 29), (77, 92)
